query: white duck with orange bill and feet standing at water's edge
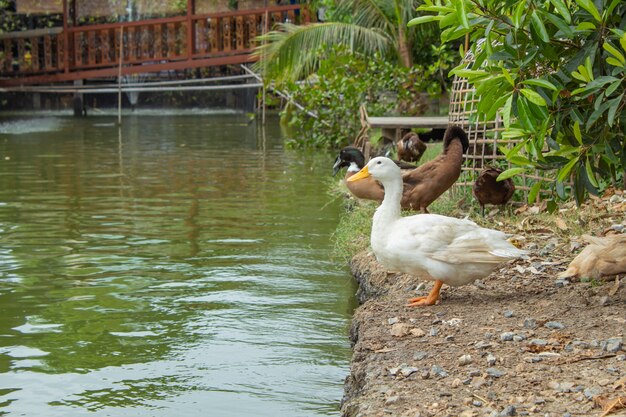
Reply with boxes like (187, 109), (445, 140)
(347, 157), (526, 306)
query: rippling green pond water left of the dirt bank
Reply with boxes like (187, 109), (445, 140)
(0, 111), (355, 417)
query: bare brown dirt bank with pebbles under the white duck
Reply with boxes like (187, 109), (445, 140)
(342, 202), (626, 417)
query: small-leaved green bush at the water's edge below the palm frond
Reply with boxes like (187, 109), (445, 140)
(282, 47), (440, 148)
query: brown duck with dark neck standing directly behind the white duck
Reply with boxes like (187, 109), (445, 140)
(333, 126), (469, 213)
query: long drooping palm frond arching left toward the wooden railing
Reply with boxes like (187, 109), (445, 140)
(254, 22), (390, 82)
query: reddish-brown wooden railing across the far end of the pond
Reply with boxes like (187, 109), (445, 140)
(0, 5), (311, 86)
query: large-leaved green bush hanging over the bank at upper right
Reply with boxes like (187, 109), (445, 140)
(409, 0), (626, 207)
